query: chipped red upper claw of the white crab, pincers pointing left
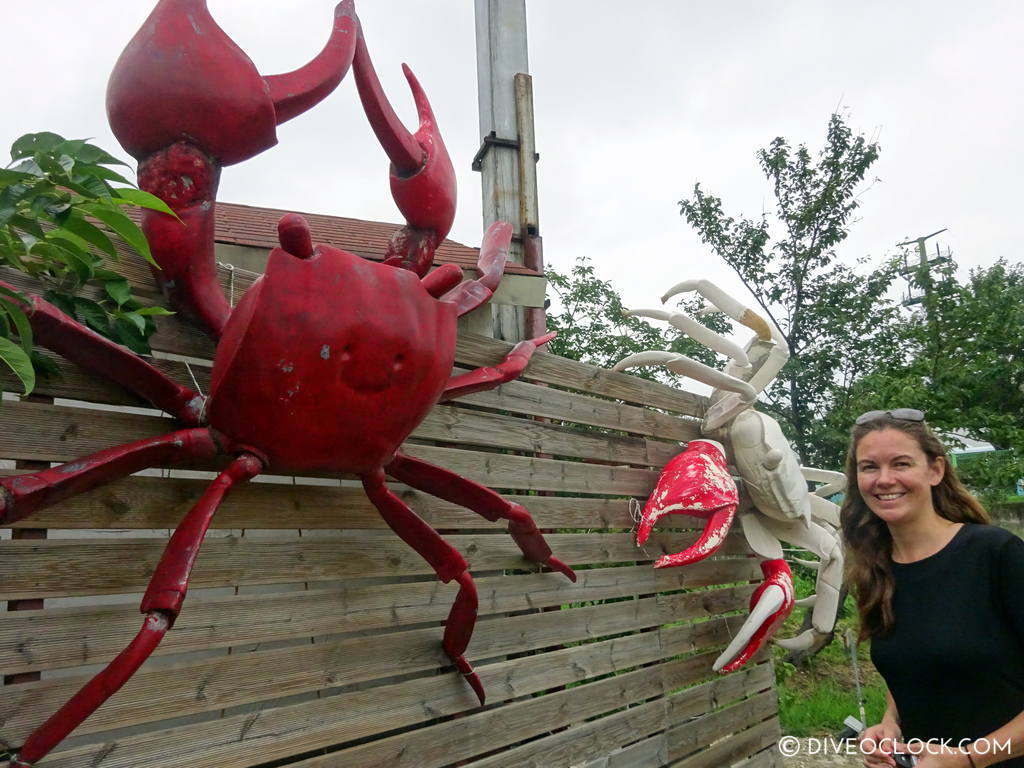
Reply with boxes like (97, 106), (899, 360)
(637, 440), (739, 568)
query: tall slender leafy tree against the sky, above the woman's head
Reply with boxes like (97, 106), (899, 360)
(679, 115), (896, 467)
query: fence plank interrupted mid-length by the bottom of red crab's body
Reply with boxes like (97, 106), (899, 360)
(0, 402), (657, 496)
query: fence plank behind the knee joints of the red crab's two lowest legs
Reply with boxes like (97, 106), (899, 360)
(0, 558), (760, 674)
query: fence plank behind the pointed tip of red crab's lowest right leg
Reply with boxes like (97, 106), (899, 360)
(37, 618), (745, 768)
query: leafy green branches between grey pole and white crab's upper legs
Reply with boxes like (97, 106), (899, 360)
(547, 257), (728, 384)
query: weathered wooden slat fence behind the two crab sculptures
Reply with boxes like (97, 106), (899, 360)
(0, 262), (781, 768)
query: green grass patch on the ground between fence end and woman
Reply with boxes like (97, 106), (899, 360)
(772, 565), (886, 736)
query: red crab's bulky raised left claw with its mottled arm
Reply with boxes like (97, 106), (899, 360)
(106, 0), (357, 337)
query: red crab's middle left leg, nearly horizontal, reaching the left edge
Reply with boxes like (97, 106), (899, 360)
(0, 428), (218, 525)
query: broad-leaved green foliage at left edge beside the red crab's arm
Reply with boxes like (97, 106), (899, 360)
(0, 133), (174, 394)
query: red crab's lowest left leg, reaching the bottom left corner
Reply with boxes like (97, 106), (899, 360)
(11, 454), (263, 768)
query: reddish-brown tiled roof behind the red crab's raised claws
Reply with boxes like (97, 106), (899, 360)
(216, 202), (538, 274)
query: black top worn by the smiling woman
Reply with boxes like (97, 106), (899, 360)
(871, 523), (1024, 768)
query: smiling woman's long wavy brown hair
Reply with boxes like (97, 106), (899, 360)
(840, 415), (989, 640)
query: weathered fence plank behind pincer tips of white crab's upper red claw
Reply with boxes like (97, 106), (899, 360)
(0, 530), (750, 600)
